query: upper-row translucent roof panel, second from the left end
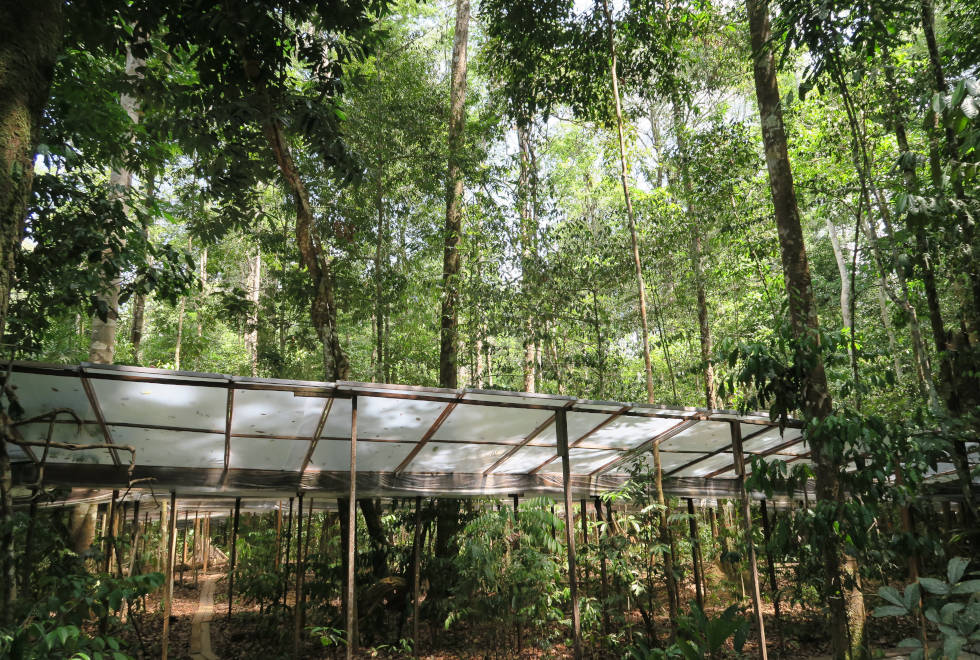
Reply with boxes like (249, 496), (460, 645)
(89, 379), (228, 434)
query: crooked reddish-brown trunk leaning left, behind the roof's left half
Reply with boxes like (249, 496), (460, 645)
(235, 47), (350, 381)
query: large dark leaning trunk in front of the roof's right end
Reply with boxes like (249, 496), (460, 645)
(745, 0), (865, 658)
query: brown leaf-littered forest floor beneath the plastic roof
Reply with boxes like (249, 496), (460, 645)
(117, 566), (964, 660)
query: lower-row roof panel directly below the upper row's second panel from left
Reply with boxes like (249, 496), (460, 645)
(109, 426), (225, 468)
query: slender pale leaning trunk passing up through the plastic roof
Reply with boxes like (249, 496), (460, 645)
(602, 0), (680, 634)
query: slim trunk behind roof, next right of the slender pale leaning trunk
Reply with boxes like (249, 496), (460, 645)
(671, 97), (718, 410)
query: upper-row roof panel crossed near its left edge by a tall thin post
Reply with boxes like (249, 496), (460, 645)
(352, 396), (446, 442)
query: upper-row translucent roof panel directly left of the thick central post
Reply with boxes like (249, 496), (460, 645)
(433, 403), (554, 444)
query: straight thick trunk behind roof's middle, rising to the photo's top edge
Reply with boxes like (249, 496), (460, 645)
(439, 0), (470, 388)
